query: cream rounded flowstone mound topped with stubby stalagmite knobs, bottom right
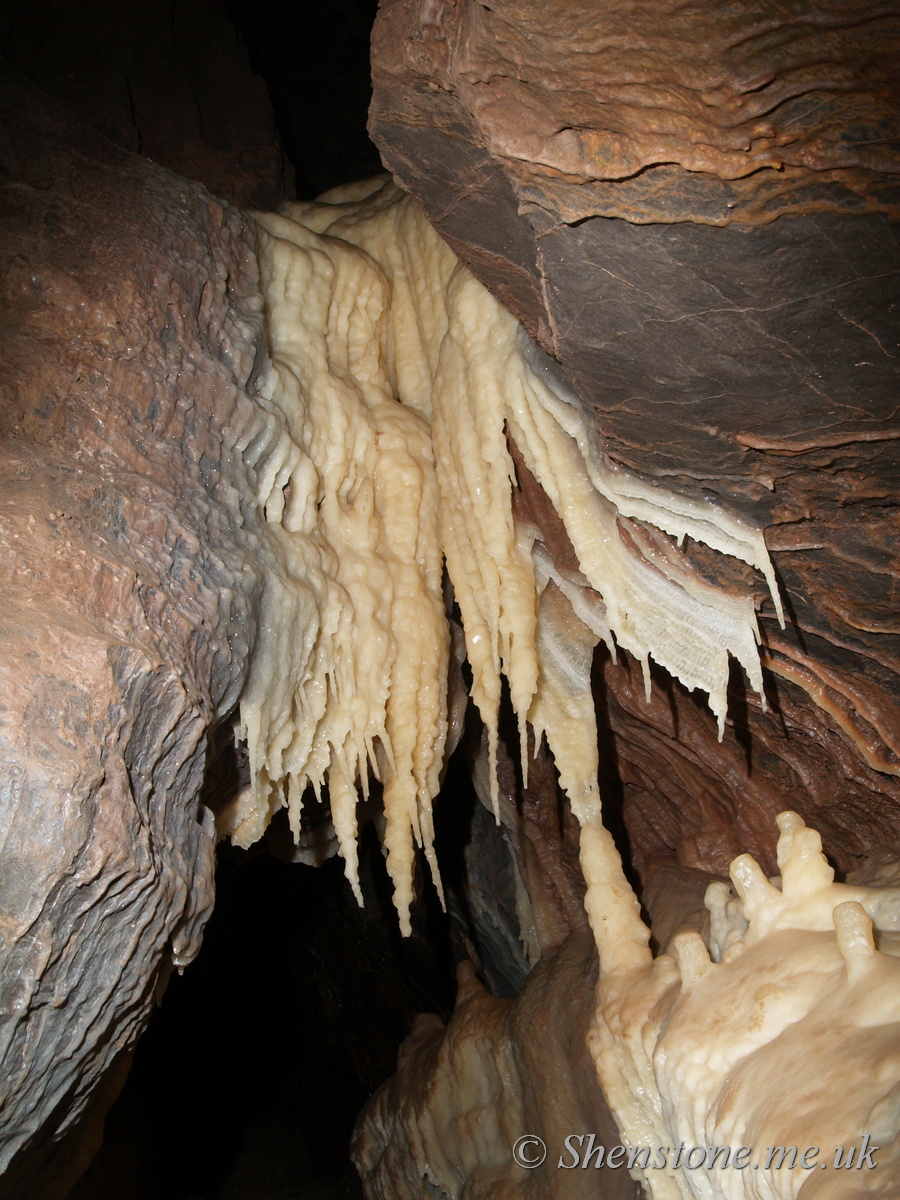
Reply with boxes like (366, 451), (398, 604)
(588, 812), (900, 1200)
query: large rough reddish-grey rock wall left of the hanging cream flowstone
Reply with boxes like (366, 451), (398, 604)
(0, 73), (271, 1198)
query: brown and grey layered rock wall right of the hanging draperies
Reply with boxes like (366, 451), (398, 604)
(370, 0), (900, 875)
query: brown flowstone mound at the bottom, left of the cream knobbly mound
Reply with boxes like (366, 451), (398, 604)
(354, 934), (640, 1200)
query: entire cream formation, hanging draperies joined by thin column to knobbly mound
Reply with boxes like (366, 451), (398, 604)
(220, 181), (900, 1200)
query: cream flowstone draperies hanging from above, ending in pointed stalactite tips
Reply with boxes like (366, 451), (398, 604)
(220, 181), (776, 931)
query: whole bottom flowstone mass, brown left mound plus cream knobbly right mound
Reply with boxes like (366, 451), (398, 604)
(354, 812), (900, 1200)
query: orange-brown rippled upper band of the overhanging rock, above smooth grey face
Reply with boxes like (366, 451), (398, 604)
(371, 0), (900, 231)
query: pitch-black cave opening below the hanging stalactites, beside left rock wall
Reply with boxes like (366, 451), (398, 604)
(72, 829), (454, 1200)
